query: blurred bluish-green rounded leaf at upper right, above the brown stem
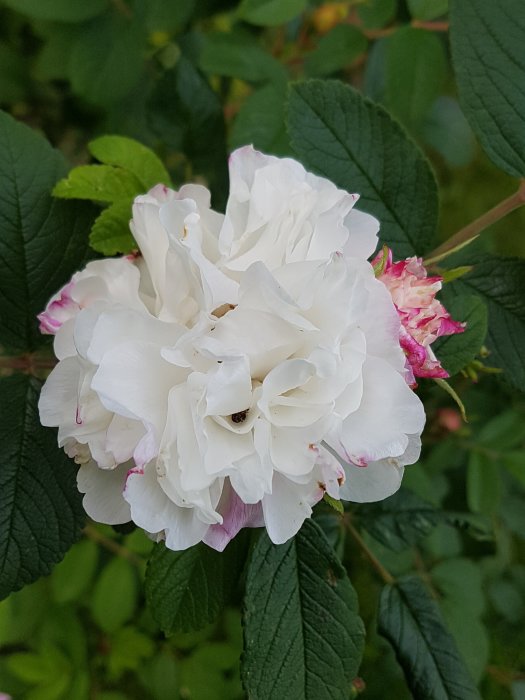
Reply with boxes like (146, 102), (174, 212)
(421, 95), (476, 168)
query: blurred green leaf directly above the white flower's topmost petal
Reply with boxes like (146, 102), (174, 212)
(230, 85), (290, 155)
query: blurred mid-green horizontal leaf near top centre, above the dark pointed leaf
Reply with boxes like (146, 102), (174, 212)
(199, 32), (286, 83)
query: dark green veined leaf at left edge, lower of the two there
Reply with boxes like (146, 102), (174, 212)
(0, 375), (84, 598)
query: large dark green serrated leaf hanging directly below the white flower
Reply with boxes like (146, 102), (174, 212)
(242, 520), (364, 700)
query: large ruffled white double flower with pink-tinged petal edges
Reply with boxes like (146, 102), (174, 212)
(40, 147), (425, 550)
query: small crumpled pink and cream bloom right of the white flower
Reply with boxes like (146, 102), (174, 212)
(372, 246), (465, 385)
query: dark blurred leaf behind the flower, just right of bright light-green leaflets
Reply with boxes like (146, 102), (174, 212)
(148, 56), (228, 209)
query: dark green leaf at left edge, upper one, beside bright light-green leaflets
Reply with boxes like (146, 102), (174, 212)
(0, 112), (93, 351)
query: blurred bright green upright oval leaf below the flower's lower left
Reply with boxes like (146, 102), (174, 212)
(91, 557), (138, 632)
